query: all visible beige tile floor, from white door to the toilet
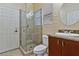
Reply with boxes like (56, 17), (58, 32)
(0, 49), (47, 56)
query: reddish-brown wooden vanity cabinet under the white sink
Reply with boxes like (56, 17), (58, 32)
(48, 35), (79, 56)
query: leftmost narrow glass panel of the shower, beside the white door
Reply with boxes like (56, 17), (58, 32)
(20, 10), (27, 49)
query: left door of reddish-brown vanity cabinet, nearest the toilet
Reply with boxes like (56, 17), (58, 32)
(49, 36), (61, 56)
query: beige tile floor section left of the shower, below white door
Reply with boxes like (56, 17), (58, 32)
(0, 49), (23, 56)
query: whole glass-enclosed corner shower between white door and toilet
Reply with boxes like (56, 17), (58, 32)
(20, 3), (42, 52)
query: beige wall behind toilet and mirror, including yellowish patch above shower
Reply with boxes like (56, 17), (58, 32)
(34, 3), (79, 34)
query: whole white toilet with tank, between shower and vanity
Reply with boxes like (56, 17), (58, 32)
(33, 35), (48, 56)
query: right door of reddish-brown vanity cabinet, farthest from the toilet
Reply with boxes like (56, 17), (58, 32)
(62, 40), (79, 56)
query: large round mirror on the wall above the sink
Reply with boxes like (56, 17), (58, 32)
(60, 3), (79, 25)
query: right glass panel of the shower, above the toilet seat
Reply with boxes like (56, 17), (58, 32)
(34, 9), (42, 45)
